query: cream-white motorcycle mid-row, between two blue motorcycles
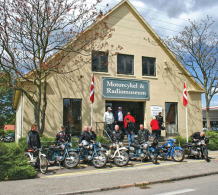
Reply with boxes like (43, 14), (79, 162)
(104, 141), (129, 167)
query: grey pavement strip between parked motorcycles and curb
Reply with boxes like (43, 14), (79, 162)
(0, 151), (218, 195)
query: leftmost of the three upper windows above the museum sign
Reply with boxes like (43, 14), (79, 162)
(92, 51), (108, 72)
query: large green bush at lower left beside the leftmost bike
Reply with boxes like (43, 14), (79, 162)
(0, 143), (37, 180)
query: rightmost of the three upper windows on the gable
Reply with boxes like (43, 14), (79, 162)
(142, 57), (156, 76)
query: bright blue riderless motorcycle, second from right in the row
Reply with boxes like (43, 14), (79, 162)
(157, 139), (184, 162)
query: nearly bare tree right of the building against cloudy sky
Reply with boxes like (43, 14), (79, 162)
(166, 16), (218, 129)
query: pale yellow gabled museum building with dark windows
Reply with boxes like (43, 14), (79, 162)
(14, 0), (203, 142)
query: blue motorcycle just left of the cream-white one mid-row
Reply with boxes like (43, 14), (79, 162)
(73, 140), (107, 168)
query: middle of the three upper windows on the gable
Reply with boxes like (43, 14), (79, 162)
(117, 54), (134, 75)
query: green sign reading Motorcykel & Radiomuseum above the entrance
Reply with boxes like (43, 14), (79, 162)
(102, 77), (150, 100)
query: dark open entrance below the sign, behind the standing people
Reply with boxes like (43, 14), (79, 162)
(105, 101), (144, 132)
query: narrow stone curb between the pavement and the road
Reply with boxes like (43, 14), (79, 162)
(62, 171), (218, 195)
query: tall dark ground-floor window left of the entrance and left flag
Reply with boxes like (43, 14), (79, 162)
(63, 99), (82, 136)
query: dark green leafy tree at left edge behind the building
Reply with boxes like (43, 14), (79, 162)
(0, 72), (15, 129)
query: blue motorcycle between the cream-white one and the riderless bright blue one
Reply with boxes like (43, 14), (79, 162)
(129, 135), (158, 164)
